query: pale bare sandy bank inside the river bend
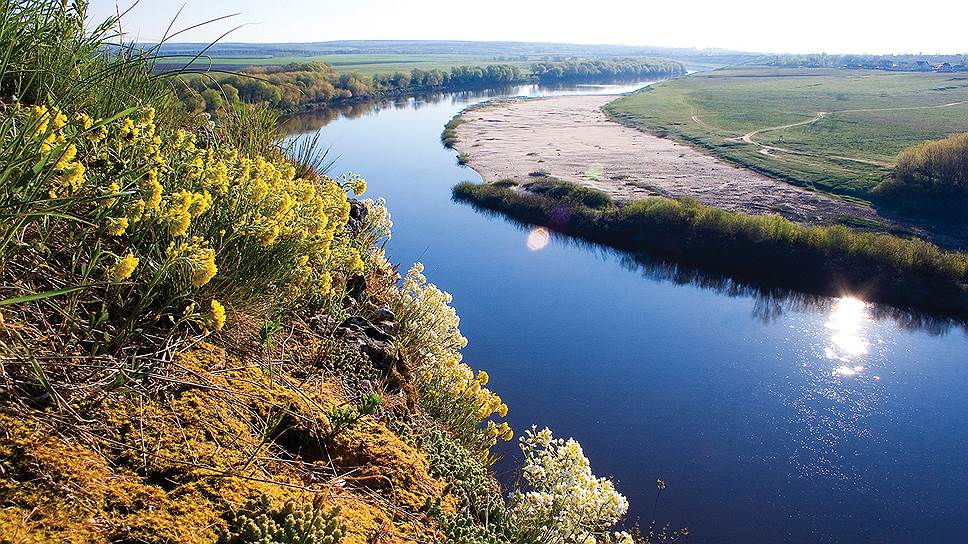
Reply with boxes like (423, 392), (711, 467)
(456, 96), (883, 224)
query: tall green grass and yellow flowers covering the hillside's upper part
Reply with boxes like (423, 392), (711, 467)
(0, 0), (374, 366)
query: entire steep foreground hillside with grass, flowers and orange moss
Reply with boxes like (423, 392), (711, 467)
(0, 4), (664, 544)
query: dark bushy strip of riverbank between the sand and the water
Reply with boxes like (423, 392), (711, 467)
(454, 179), (968, 318)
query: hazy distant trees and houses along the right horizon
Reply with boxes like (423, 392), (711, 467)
(766, 53), (968, 72)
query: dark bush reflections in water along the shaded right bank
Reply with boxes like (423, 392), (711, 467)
(460, 202), (968, 336)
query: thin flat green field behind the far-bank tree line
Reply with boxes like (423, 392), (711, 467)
(166, 54), (534, 76)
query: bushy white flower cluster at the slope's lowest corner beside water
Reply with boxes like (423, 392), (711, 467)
(510, 427), (632, 544)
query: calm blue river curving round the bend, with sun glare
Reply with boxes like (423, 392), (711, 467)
(289, 83), (968, 544)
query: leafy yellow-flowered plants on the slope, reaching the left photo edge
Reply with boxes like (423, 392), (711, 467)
(0, 100), (365, 351)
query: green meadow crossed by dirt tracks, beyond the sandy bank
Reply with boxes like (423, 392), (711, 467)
(606, 68), (968, 198)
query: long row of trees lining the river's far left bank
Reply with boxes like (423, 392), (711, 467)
(179, 59), (686, 114)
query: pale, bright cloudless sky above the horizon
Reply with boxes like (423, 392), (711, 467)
(91, 0), (968, 53)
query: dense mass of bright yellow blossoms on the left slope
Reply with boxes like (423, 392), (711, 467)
(15, 101), (367, 336)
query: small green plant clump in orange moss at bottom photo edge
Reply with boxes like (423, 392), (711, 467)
(218, 494), (346, 544)
